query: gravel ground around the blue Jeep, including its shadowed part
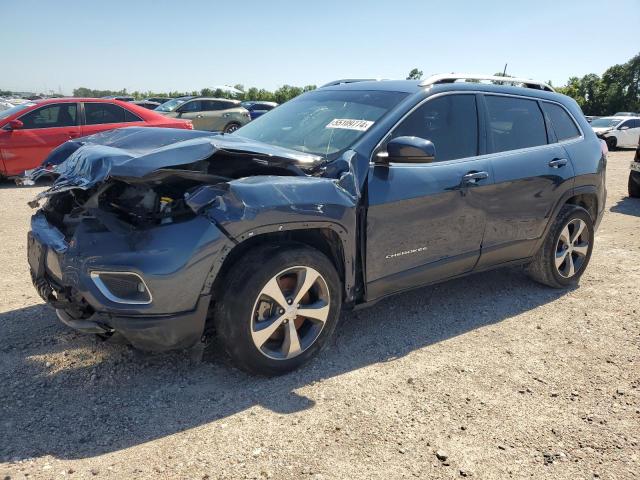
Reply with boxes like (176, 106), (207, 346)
(0, 151), (640, 480)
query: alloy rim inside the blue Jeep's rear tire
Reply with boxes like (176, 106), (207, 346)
(555, 218), (589, 278)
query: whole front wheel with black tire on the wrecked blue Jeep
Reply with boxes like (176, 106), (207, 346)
(214, 244), (342, 376)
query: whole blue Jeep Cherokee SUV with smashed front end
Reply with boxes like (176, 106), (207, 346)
(28, 75), (606, 375)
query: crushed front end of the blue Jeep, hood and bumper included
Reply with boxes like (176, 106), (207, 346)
(28, 128), (338, 350)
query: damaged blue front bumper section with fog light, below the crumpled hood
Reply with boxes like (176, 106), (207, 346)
(28, 183), (233, 350)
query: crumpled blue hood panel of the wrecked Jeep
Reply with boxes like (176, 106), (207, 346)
(32, 127), (322, 197)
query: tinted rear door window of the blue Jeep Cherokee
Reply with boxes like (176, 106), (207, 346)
(485, 95), (547, 152)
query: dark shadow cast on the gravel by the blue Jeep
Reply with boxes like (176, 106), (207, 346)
(0, 268), (566, 461)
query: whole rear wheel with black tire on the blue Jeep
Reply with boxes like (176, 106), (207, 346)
(527, 205), (594, 288)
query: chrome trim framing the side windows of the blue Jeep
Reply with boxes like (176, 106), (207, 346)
(369, 90), (584, 168)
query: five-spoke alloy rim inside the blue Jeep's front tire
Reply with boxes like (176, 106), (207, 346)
(251, 266), (331, 360)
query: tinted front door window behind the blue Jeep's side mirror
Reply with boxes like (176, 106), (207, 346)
(392, 95), (478, 161)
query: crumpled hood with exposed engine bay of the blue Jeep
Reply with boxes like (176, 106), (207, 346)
(30, 128), (350, 238)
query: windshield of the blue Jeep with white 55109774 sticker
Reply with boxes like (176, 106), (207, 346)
(235, 89), (407, 158)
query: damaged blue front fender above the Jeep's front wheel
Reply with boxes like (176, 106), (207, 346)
(186, 171), (357, 300)
